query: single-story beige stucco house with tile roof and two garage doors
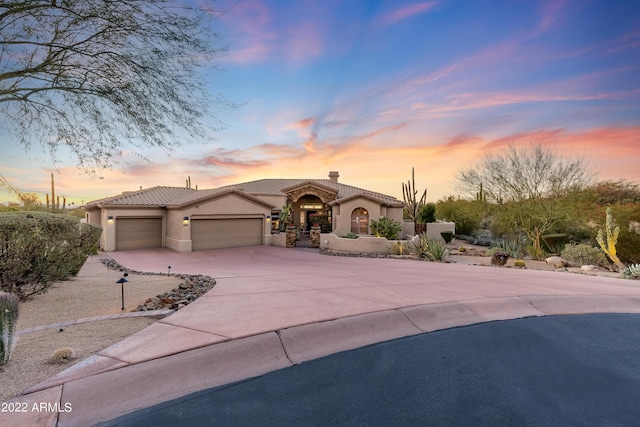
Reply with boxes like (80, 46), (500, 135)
(84, 171), (404, 252)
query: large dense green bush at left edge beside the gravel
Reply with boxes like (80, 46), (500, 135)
(0, 212), (101, 300)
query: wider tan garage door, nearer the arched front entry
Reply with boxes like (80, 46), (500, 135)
(191, 218), (262, 251)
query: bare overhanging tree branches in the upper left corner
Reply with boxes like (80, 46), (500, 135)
(0, 0), (230, 170)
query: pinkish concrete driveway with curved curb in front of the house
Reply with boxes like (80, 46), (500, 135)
(1, 246), (640, 426)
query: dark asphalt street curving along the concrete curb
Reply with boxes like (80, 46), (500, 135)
(99, 314), (640, 426)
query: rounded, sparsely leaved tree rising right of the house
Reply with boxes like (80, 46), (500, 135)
(457, 145), (591, 258)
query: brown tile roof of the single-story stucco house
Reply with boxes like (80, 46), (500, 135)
(84, 179), (403, 209)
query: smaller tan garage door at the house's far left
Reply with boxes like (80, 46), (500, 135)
(116, 218), (162, 251)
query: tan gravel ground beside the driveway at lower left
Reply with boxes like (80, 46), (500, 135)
(0, 255), (182, 401)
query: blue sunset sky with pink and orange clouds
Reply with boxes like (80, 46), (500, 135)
(0, 0), (640, 204)
